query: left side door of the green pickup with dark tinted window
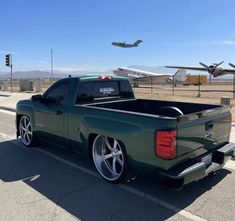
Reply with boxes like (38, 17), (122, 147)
(34, 79), (70, 144)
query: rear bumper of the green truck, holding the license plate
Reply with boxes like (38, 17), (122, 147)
(157, 143), (235, 189)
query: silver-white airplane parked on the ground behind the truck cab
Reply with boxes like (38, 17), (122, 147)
(113, 67), (187, 86)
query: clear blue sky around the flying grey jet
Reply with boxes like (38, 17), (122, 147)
(0, 0), (235, 72)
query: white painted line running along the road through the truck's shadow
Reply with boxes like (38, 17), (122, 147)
(0, 133), (207, 221)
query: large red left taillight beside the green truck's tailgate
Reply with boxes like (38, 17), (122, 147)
(155, 130), (177, 160)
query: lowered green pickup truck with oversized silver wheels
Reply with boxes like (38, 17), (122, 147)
(16, 76), (235, 188)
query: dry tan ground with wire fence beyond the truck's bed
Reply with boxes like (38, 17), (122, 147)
(134, 83), (235, 116)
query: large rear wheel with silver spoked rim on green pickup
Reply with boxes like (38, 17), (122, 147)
(92, 135), (128, 183)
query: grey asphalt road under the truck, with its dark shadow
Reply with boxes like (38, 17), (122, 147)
(0, 111), (235, 221)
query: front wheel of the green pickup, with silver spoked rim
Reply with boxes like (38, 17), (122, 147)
(19, 116), (36, 147)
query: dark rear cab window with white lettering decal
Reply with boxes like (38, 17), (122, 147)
(77, 81), (133, 103)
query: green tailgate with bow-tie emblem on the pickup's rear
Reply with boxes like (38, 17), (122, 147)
(177, 106), (230, 157)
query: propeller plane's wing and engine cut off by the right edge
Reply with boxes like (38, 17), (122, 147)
(165, 61), (235, 77)
